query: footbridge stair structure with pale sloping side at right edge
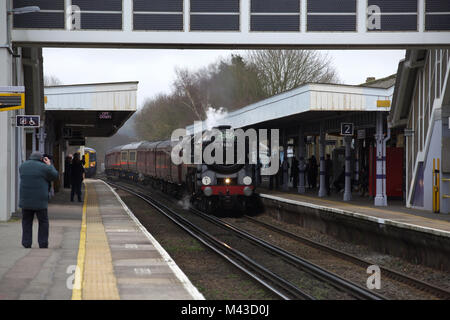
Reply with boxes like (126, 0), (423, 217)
(389, 49), (450, 213)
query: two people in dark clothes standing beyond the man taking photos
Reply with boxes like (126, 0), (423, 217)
(64, 153), (85, 202)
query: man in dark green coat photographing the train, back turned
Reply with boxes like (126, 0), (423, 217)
(19, 152), (58, 248)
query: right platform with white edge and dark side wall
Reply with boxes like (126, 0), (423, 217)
(257, 188), (450, 270)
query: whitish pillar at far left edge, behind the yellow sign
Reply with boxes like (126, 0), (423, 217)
(0, 1), (15, 221)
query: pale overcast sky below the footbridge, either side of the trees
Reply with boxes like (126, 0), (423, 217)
(44, 48), (405, 108)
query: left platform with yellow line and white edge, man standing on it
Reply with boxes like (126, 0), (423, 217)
(0, 179), (204, 300)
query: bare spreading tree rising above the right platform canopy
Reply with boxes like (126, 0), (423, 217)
(246, 50), (339, 96)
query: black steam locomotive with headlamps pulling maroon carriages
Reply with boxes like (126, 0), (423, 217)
(105, 127), (255, 213)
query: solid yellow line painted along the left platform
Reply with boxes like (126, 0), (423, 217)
(72, 183), (88, 300)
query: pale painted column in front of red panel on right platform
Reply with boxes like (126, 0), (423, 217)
(374, 112), (387, 206)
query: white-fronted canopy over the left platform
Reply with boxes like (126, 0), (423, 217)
(44, 82), (138, 138)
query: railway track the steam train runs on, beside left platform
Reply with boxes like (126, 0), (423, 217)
(106, 181), (384, 300)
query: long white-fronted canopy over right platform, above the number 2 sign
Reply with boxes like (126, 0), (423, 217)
(186, 75), (396, 134)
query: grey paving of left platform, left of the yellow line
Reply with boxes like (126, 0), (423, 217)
(0, 191), (82, 300)
